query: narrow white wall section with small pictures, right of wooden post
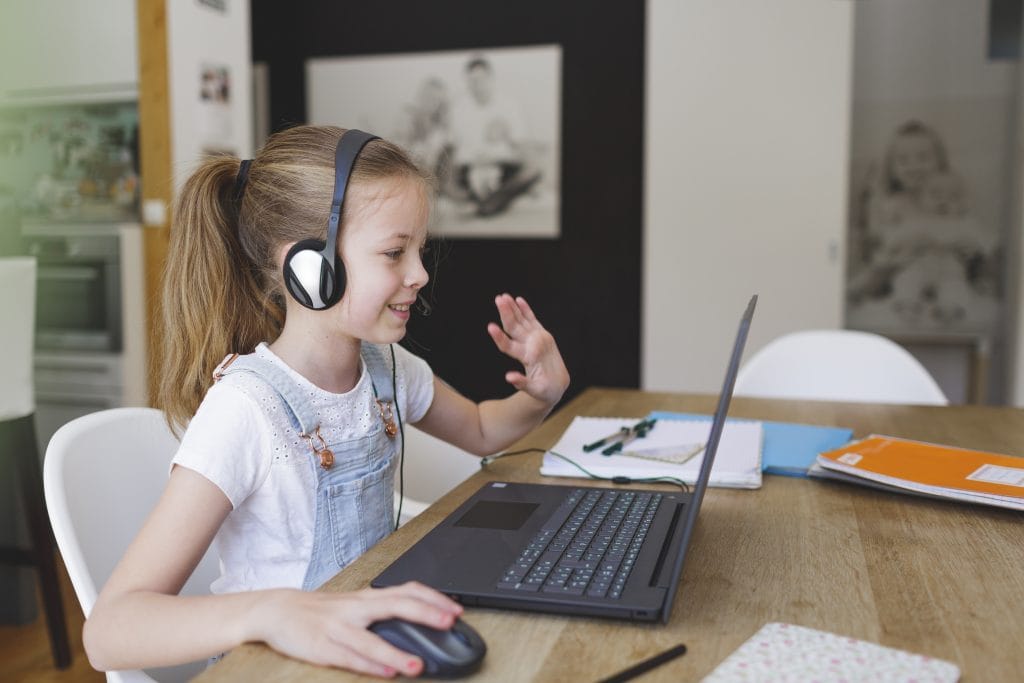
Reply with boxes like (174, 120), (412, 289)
(167, 0), (253, 186)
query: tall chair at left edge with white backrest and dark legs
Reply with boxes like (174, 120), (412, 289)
(0, 257), (71, 669)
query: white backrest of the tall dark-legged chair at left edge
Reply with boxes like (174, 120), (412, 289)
(0, 256), (36, 420)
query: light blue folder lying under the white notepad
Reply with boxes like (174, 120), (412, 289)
(647, 411), (853, 477)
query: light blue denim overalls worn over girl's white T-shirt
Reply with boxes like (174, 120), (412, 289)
(215, 343), (400, 591)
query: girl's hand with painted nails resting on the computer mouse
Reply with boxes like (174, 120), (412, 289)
(256, 583), (462, 678)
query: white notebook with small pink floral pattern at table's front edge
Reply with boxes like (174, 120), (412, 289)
(703, 624), (959, 683)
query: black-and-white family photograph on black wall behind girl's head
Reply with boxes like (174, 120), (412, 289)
(306, 45), (561, 239)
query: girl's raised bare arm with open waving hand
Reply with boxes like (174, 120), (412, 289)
(416, 294), (569, 456)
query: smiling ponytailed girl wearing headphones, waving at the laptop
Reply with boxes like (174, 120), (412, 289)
(84, 126), (568, 677)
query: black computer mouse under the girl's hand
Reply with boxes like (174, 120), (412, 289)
(370, 618), (487, 678)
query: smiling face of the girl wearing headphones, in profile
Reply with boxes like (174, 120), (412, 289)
(336, 179), (429, 344)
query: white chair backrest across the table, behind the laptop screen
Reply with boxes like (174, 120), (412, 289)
(735, 330), (949, 405)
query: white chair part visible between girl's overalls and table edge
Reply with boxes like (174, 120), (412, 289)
(394, 425), (480, 524)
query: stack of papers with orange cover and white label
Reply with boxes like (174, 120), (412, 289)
(810, 435), (1024, 510)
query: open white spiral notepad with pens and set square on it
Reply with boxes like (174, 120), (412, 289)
(541, 417), (764, 488)
